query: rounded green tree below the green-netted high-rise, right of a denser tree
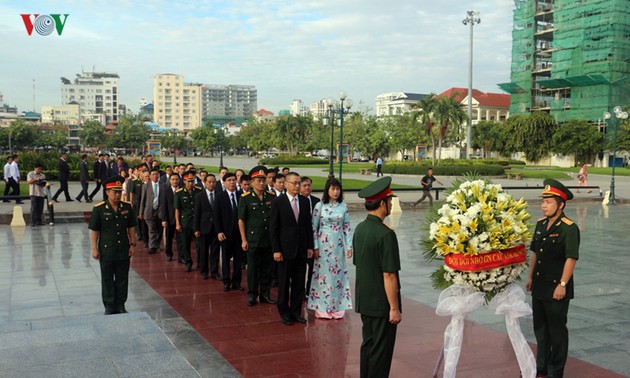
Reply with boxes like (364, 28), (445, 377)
(551, 120), (604, 163)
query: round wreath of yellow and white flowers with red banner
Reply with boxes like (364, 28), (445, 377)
(422, 176), (532, 302)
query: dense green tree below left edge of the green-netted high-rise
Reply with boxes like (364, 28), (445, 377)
(504, 112), (557, 162)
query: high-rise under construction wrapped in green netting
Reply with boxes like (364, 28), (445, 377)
(499, 0), (630, 122)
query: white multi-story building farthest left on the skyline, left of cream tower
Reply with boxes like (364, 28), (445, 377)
(61, 72), (119, 124)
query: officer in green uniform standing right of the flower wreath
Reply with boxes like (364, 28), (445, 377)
(526, 179), (580, 378)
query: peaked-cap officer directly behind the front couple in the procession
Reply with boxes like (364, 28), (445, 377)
(238, 166), (276, 306)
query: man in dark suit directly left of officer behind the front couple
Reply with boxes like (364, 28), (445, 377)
(214, 173), (243, 291)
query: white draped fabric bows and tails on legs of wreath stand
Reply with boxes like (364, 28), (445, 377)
(433, 284), (536, 378)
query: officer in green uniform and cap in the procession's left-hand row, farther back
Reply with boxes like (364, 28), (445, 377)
(173, 170), (202, 272)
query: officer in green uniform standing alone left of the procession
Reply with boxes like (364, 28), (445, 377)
(89, 176), (136, 315)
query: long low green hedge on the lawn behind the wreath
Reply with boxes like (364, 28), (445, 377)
(382, 159), (505, 176)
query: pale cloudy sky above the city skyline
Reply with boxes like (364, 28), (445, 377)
(0, 0), (514, 112)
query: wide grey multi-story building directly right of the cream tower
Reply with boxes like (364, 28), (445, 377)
(201, 84), (258, 119)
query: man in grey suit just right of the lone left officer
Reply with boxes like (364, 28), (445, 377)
(138, 168), (162, 254)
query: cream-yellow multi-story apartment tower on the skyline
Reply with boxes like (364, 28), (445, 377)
(153, 74), (202, 131)
